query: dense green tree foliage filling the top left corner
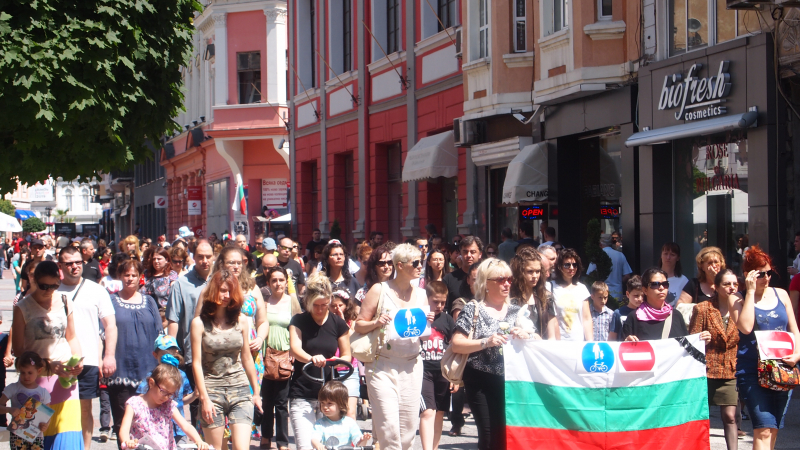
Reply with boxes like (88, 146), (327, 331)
(0, 0), (202, 192)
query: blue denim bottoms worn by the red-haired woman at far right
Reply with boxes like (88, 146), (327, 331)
(736, 374), (791, 429)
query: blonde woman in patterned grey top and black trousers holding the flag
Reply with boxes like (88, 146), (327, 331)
(450, 258), (529, 450)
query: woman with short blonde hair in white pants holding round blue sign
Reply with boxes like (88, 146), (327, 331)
(355, 244), (433, 450)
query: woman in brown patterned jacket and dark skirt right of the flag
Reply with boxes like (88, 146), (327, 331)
(689, 269), (741, 450)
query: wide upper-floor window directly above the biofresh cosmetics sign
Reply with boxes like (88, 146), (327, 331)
(667, 0), (760, 56)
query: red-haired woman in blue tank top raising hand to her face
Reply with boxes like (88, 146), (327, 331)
(731, 245), (800, 450)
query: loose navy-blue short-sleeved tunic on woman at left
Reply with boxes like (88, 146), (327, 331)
(107, 294), (163, 388)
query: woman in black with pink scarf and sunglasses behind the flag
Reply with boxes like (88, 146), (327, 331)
(621, 267), (692, 341)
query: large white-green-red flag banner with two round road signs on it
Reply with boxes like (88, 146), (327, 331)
(503, 334), (709, 450)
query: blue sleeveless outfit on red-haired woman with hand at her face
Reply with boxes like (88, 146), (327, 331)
(736, 288), (791, 429)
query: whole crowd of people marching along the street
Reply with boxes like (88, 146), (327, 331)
(0, 227), (800, 450)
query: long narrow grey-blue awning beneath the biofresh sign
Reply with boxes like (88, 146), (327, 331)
(625, 111), (758, 147)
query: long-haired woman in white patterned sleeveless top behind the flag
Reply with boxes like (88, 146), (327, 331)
(553, 248), (594, 342)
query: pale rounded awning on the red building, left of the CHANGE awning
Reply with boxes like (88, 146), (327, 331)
(403, 130), (458, 182)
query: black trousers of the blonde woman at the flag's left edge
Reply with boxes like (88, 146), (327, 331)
(464, 364), (506, 450)
